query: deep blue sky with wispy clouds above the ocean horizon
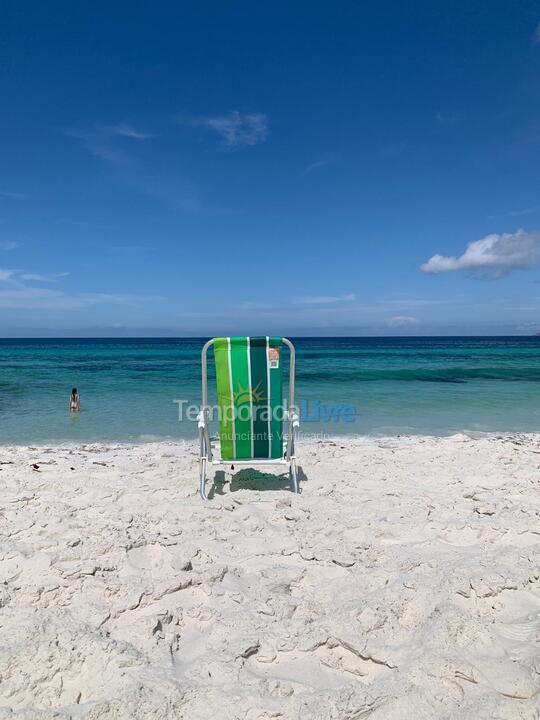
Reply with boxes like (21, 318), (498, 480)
(0, 0), (540, 336)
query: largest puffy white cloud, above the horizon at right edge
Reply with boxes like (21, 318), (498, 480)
(420, 230), (540, 278)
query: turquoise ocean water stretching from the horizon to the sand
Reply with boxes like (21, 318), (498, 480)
(0, 337), (540, 444)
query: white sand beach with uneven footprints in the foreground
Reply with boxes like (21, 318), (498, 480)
(0, 435), (540, 720)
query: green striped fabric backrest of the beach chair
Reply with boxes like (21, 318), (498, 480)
(213, 336), (284, 460)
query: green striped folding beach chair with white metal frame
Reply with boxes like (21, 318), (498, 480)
(198, 336), (299, 500)
